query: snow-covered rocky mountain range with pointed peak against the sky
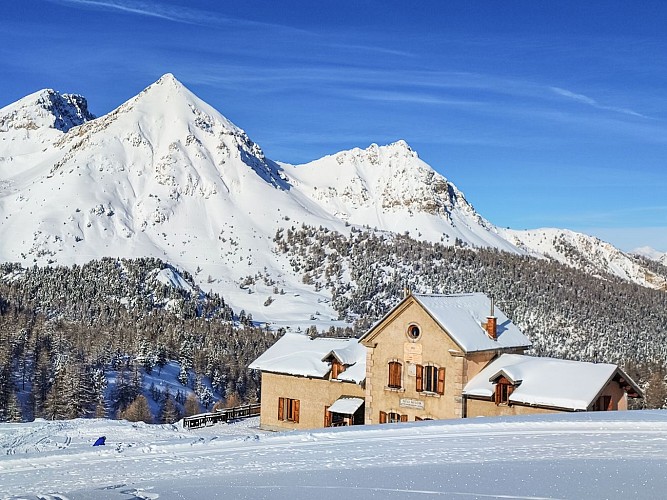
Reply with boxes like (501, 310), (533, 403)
(0, 74), (667, 322)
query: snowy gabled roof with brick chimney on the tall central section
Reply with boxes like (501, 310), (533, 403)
(362, 292), (532, 353)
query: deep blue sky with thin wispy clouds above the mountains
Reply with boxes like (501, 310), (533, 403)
(0, 0), (667, 252)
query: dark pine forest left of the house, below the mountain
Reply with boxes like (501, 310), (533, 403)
(0, 259), (277, 422)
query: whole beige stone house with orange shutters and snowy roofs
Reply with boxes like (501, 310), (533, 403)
(250, 292), (642, 429)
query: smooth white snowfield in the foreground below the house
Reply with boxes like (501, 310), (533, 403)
(0, 411), (667, 500)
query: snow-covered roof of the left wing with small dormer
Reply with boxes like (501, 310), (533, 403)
(249, 333), (366, 384)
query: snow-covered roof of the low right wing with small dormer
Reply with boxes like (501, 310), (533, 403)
(463, 354), (638, 410)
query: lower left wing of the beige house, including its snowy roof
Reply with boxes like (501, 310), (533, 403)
(249, 333), (366, 430)
